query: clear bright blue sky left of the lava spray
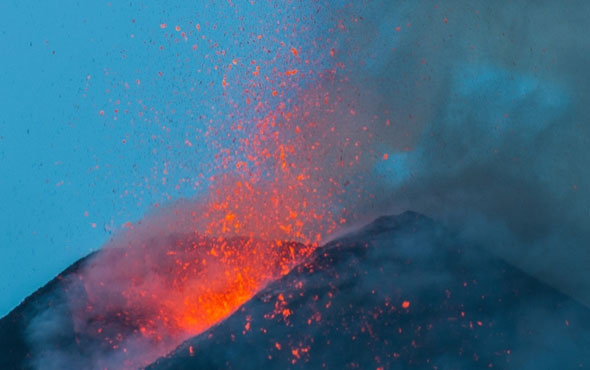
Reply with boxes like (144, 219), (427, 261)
(0, 0), (332, 315)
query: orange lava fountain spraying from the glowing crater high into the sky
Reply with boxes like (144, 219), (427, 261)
(54, 2), (394, 367)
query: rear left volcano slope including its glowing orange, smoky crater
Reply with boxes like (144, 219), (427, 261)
(0, 232), (311, 370)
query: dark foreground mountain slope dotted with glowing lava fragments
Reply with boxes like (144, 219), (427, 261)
(148, 212), (590, 370)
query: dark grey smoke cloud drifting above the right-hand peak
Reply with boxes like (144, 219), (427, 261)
(322, 0), (590, 304)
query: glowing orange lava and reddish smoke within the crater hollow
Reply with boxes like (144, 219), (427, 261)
(69, 233), (312, 368)
